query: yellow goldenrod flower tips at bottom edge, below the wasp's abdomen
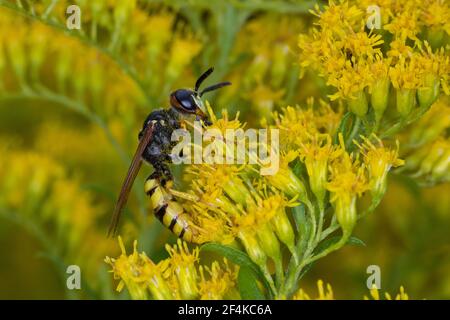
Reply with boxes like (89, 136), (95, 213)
(105, 237), (239, 300)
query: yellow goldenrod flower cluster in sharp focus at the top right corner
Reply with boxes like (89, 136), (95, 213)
(298, 1), (450, 130)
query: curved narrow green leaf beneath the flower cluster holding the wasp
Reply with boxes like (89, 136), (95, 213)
(200, 242), (272, 298)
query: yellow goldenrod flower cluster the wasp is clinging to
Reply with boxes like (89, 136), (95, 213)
(108, 101), (403, 298)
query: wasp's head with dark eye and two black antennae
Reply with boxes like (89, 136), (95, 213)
(170, 68), (231, 125)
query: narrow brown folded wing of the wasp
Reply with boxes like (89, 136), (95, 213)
(108, 124), (153, 237)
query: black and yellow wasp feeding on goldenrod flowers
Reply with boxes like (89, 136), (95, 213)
(108, 68), (231, 242)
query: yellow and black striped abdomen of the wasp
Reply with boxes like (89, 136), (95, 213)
(144, 178), (198, 243)
